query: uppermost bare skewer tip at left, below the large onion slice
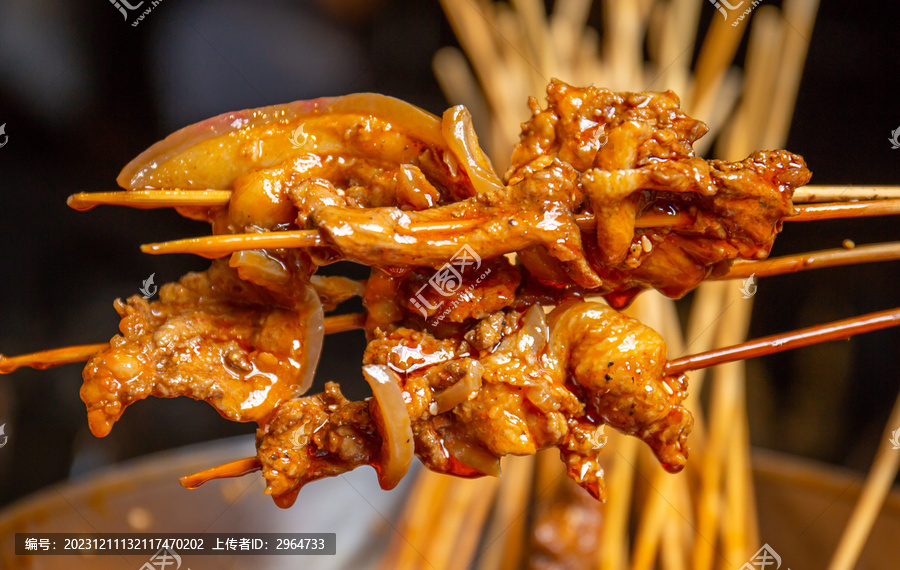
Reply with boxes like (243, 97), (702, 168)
(66, 188), (231, 211)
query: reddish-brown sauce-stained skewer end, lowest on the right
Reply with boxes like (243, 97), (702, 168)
(666, 308), (900, 375)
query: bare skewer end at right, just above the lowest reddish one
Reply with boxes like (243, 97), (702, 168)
(711, 241), (900, 280)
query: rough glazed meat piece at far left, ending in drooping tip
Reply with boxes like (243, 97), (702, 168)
(81, 261), (323, 437)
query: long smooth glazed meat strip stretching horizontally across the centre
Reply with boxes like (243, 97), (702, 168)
(307, 159), (600, 287)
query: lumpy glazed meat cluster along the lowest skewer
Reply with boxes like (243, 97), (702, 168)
(258, 303), (693, 502)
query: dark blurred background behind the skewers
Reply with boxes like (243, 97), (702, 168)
(0, 0), (900, 505)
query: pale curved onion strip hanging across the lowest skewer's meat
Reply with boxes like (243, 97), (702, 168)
(363, 364), (416, 491)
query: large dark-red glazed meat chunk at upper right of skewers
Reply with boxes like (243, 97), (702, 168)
(506, 81), (810, 307)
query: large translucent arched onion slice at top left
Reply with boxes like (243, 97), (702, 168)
(116, 93), (446, 190)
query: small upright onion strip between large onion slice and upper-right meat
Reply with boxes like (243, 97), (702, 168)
(441, 105), (503, 194)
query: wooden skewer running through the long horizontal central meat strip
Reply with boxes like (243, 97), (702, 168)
(141, 199), (900, 259)
